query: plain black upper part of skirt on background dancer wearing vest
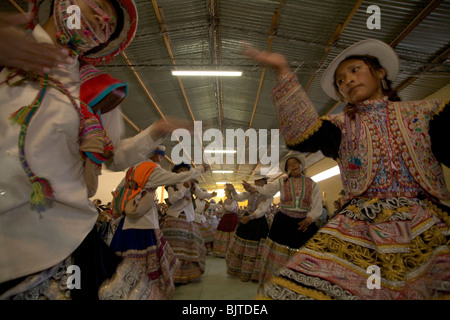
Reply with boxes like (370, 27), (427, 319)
(269, 211), (319, 249)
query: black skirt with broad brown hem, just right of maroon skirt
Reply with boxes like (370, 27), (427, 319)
(226, 216), (269, 281)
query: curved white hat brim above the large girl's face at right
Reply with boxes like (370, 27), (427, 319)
(320, 39), (399, 101)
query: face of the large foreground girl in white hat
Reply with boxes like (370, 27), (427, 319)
(336, 60), (386, 104)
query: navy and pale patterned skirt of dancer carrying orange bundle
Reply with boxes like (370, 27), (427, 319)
(99, 219), (179, 300)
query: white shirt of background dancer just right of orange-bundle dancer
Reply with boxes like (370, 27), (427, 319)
(166, 182), (212, 222)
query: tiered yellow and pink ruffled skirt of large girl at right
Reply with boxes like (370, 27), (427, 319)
(259, 198), (450, 300)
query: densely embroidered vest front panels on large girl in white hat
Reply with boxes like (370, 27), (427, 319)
(327, 100), (450, 199)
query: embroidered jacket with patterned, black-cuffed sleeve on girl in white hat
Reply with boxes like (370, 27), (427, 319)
(273, 73), (450, 200)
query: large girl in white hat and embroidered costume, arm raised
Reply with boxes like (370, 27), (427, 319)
(247, 39), (450, 299)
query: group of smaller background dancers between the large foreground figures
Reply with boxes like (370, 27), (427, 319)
(94, 146), (323, 299)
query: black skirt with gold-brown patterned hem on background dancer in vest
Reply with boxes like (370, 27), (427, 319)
(259, 211), (318, 286)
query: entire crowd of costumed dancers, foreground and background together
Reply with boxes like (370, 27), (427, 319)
(0, 0), (450, 300)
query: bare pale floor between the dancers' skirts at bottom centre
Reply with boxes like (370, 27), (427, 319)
(172, 255), (258, 300)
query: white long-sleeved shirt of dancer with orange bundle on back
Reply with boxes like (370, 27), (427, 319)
(122, 165), (203, 230)
